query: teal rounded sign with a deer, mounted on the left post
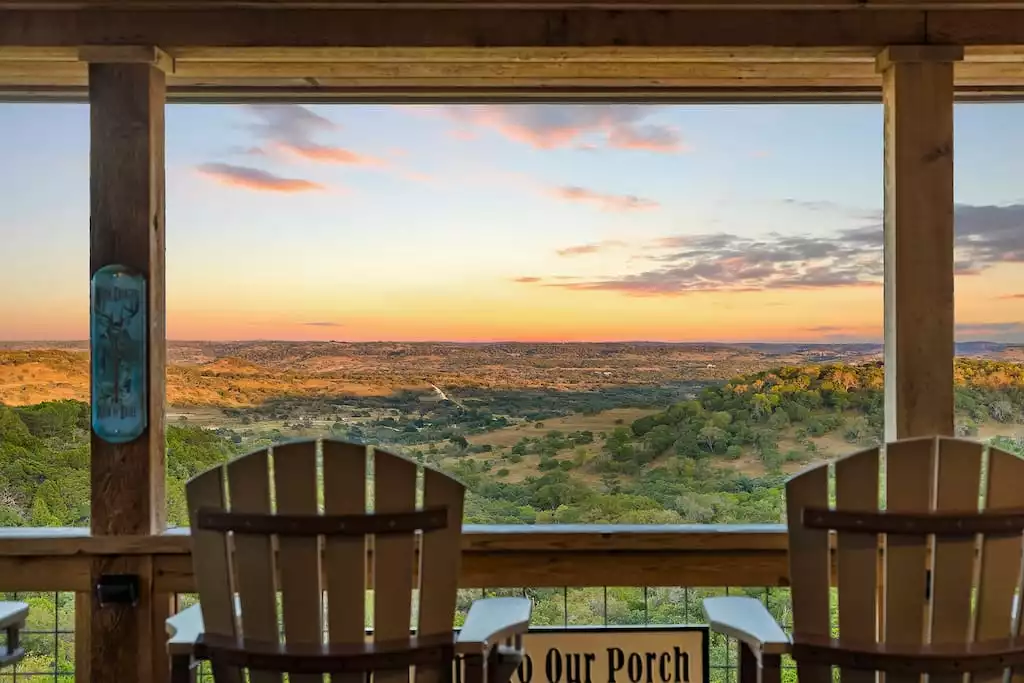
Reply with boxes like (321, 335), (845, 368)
(89, 265), (148, 443)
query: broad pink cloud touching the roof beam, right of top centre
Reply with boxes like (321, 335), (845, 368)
(443, 104), (686, 153)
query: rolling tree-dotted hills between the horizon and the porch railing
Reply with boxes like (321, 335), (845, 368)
(0, 343), (1024, 524)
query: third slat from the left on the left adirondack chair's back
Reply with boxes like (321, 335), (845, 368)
(272, 441), (324, 683)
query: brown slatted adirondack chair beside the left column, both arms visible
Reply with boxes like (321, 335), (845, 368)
(167, 440), (530, 683)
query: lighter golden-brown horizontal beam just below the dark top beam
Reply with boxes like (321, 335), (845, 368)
(6, 48), (1024, 101)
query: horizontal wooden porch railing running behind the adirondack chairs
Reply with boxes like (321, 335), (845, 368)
(0, 524), (788, 683)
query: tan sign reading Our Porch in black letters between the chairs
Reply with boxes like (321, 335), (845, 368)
(511, 626), (709, 683)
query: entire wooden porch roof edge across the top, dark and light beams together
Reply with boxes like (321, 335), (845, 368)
(0, 0), (1024, 101)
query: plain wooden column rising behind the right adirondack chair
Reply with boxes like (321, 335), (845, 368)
(878, 45), (964, 440)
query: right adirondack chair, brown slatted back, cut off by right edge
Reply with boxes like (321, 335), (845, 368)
(705, 437), (1024, 683)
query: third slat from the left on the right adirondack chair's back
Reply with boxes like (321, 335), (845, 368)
(885, 438), (936, 683)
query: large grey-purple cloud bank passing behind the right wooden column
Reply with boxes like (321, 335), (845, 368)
(512, 202), (1024, 298)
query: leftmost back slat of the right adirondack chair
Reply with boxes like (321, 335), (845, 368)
(785, 467), (831, 683)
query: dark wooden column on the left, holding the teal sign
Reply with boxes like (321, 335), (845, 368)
(79, 46), (169, 683)
